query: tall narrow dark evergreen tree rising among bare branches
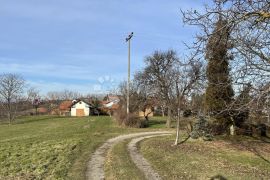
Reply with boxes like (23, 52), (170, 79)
(205, 16), (234, 125)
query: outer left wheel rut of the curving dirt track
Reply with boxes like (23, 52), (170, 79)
(86, 131), (172, 180)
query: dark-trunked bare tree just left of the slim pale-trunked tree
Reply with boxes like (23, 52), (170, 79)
(138, 50), (179, 128)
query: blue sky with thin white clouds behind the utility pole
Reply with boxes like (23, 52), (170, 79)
(0, 0), (209, 94)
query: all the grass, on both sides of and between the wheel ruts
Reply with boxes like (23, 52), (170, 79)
(4, 116), (270, 180)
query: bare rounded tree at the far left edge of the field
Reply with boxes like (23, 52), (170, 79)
(0, 74), (25, 124)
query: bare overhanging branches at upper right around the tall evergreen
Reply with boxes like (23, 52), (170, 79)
(182, 0), (270, 133)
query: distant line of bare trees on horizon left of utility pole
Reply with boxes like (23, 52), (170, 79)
(0, 73), (106, 124)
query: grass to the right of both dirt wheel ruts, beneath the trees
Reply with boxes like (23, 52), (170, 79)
(140, 136), (270, 179)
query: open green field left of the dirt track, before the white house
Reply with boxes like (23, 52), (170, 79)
(0, 116), (146, 180)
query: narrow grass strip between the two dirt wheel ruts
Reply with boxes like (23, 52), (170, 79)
(105, 140), (145, 180)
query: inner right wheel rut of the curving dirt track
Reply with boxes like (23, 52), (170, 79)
(128, 134), (168, 180)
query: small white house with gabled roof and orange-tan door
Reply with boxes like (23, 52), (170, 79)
(70, 100), (91, 117)
